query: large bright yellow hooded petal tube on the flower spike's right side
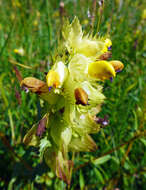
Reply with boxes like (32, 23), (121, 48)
(88, 61), (116, 80)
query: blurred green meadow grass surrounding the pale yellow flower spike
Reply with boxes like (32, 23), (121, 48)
(0, 0), (146, 190)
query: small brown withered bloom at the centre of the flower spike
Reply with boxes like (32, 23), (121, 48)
(74, 88), (88, 105)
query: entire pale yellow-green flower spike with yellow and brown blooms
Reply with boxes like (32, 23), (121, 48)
(21, 17), (123, 184)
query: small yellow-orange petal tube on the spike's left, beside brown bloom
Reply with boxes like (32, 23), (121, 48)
(46, 70), (60, 88)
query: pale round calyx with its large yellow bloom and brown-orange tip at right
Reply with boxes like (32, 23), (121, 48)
(68, 54), (117, 82)
